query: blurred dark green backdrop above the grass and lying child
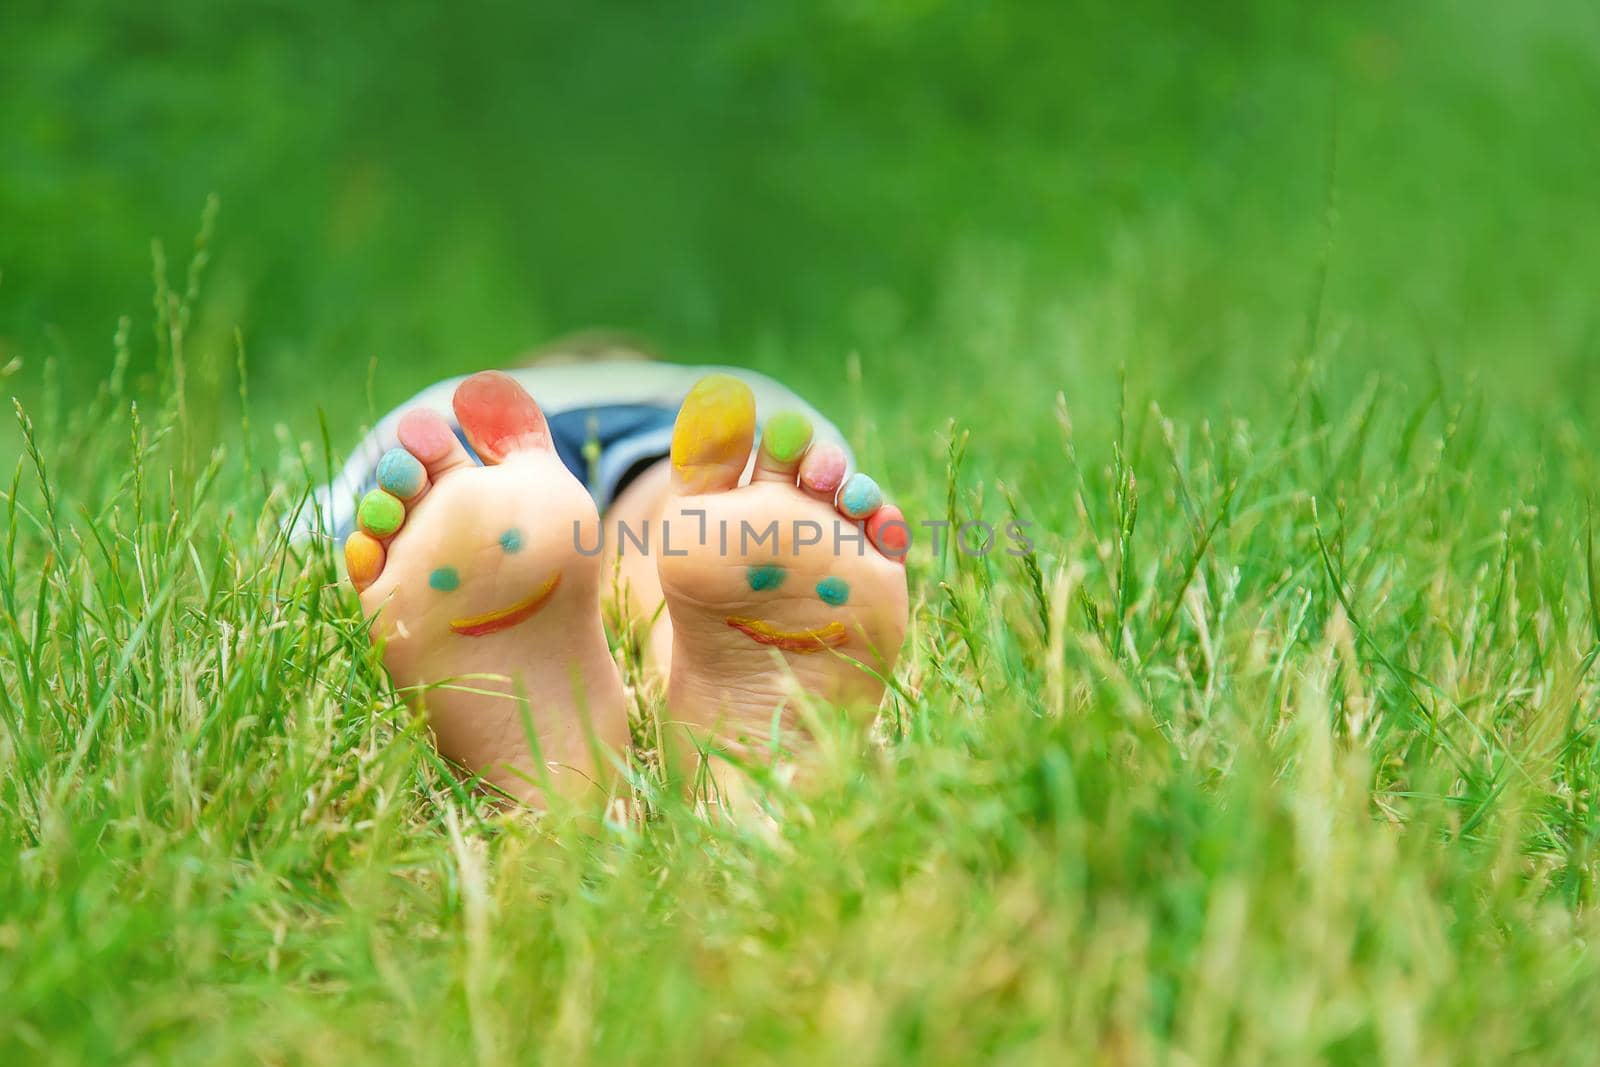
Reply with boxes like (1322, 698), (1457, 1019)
(0, 0), (1600, 456)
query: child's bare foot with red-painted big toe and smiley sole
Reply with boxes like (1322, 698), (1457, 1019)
(344, 371), (627, 803)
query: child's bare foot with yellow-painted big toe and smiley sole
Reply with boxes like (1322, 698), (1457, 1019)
(659, 374), (909, 784)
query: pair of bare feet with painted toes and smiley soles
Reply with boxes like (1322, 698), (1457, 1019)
(346, 371), (907, 805)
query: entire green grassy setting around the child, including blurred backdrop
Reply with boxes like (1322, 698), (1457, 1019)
(0, 0), (1600, 1067)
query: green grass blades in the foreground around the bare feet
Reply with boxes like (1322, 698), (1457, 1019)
(9, 235), (1600, 1062)
